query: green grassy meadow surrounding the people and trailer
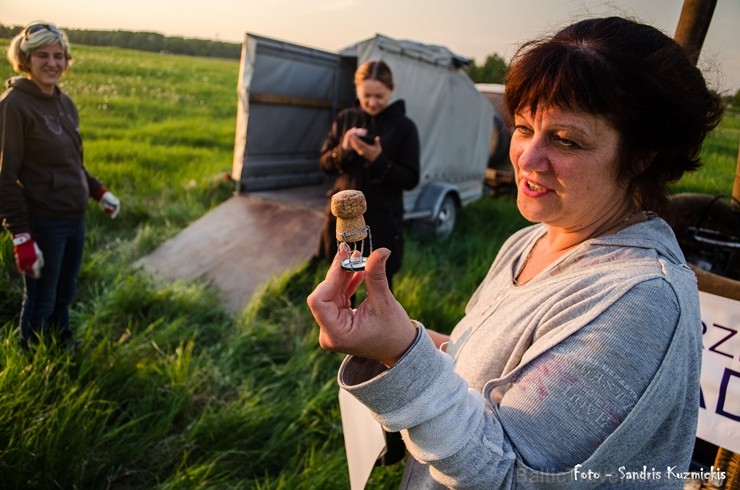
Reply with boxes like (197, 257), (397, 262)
(0, 41), (740, 490)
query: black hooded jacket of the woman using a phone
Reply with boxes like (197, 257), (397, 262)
(318, 100), (420, 275)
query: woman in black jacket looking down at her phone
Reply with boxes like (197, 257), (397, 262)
(318, 60), (420, 286)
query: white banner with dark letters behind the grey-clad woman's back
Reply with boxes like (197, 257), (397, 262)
(696, 291), (740, 452)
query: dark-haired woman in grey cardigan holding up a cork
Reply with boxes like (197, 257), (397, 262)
(308, 18), (722, 489)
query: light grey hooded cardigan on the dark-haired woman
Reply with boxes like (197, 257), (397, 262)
(339, 215), (701, 490)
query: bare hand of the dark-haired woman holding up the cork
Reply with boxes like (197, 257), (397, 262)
(307, 248), (416, 367)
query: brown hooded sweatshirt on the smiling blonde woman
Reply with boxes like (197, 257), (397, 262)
(0, 77), (103, 235)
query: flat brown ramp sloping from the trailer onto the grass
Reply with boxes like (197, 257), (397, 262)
(134, 186), (327, 314)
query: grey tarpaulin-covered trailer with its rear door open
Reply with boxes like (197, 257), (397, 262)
(232, 33), (495, 235)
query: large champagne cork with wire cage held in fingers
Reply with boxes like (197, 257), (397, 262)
(331, 190), (373, 271)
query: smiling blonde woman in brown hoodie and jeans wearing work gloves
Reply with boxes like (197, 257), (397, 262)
(0, 22), (121, 347)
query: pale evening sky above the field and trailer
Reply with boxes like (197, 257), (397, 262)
(0, 0), (740, 94)
